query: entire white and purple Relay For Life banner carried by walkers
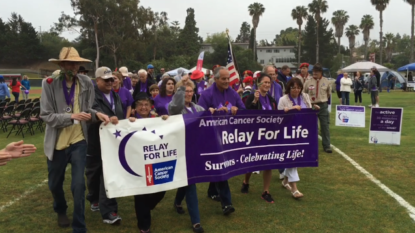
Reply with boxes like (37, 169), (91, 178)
(100, 109), (318, 198)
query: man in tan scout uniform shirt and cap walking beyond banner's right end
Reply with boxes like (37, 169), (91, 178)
(303, 63), (333, 153)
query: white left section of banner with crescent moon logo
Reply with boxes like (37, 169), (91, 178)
(100, 115), (188, 198)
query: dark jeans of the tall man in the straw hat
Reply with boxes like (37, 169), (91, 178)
(47, 140), (87, 233)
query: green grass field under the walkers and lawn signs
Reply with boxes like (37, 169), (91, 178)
(0, 91), (415, 233)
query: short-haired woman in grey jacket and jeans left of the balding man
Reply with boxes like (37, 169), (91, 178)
(169, 80), (205, 233)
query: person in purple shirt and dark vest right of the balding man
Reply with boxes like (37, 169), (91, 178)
(241, 73), (278, 203)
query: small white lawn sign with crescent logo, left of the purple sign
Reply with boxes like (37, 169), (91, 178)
(336, 105), (366, 128)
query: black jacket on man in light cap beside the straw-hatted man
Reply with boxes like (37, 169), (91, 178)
(87, 86), (125, 156)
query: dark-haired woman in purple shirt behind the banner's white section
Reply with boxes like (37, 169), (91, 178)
(154, 76), (177, 116)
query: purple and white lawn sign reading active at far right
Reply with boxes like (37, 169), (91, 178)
(369, 108), (403, 145)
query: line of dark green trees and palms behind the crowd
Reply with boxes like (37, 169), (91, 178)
(0, 0), (415, 74)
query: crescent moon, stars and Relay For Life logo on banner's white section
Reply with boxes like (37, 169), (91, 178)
(114, 127), (177, 186)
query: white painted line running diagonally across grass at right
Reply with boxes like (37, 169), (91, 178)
(318, 135), (415, 221)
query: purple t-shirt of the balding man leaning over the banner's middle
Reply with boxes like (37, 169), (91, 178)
(197, 83), (245, 109)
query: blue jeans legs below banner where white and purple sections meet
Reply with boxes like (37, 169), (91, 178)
(174, 184), (200, 225)
